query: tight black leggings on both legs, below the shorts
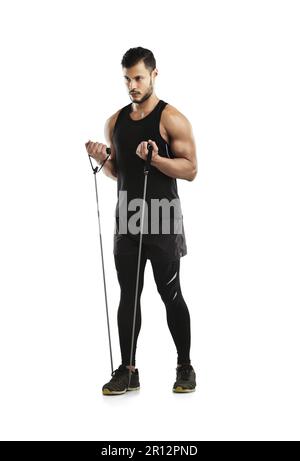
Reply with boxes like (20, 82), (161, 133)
(114, 253), (191, 365)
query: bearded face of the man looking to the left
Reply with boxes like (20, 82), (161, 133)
(123, 61), (157, 104)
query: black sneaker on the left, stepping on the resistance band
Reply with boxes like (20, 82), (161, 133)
(102, 365), (140, 395)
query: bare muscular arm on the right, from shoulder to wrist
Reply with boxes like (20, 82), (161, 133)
(151, 106), (197, 181)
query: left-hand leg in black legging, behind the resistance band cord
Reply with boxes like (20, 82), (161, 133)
(114, 252), (147, 369)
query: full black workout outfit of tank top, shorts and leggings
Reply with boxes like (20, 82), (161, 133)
(112, 100), (191, 376)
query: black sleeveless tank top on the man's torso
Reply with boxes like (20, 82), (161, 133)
(112, 100), (186, 256)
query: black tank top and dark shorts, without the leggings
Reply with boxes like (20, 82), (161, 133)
(112, 100), (187, 261)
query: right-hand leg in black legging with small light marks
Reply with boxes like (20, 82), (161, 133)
(151, 259), (191, 365)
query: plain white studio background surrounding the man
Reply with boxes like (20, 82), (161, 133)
(0, 0), (300, 440)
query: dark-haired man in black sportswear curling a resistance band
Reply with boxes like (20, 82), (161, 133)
(86, 47), (197, 395)
